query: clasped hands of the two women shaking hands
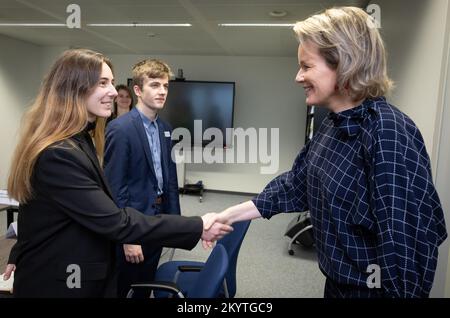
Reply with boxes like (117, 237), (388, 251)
(202, 212), (233, 249)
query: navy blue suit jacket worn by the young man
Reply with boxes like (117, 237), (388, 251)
(104, 108), (180, 215)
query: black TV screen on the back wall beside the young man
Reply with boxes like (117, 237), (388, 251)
(159, 80), (235, 147)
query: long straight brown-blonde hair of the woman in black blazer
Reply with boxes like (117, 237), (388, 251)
(8, 49), (112, 204)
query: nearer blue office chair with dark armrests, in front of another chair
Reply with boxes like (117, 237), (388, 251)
(127, 244), (229, 298)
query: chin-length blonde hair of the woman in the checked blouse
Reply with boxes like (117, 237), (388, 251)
(294, 7), (393, 101)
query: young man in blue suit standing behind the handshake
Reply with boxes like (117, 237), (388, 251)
(104, 59), (180, 297)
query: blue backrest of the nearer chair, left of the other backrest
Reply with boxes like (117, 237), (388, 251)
(186, 244), (229, 298)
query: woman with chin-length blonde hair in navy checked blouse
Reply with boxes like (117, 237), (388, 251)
(207, 7), (447, 298)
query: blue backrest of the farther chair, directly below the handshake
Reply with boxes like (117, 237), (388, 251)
(217, 220), (251, 298)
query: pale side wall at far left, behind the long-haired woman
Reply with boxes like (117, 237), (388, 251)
(0, 35), (42, 189)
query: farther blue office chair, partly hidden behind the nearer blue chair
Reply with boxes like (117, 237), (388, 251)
(155, 221), (250, 298)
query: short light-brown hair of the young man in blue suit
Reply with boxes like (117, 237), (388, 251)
(133, 59), (173, 89)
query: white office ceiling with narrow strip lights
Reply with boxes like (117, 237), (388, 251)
(0, 0), (368, 56)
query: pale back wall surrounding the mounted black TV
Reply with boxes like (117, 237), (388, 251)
(110, 52), (306, 193)
